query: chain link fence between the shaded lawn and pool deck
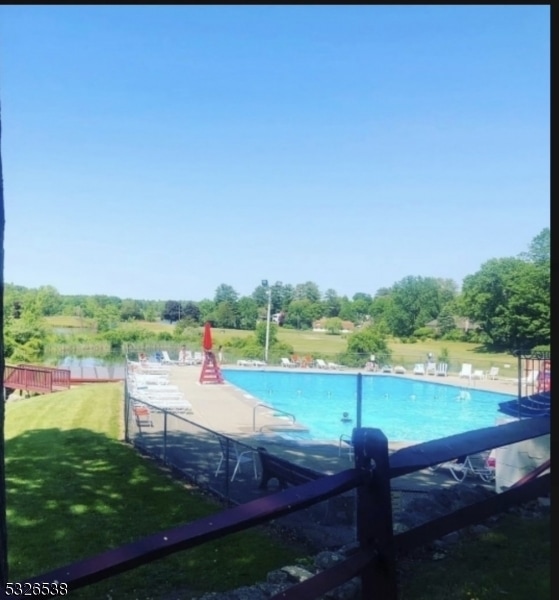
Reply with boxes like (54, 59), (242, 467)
(124, 383), (434, 549)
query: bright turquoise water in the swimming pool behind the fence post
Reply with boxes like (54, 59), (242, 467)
(223, 369), (514, 442)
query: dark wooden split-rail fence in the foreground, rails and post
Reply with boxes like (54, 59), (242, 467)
(20, 417), (550, 600)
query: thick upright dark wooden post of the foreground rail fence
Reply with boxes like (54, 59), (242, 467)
(353, 428), (398, 600)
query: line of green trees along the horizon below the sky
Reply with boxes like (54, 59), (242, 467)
(4, 228), (550, 350)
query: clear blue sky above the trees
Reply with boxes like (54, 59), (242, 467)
(0, 5), (550, 300)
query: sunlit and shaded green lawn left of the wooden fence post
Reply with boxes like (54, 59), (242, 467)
(5, 384), (299, 600)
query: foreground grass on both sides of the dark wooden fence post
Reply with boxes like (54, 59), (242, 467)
(5, 384), (550, 600)
